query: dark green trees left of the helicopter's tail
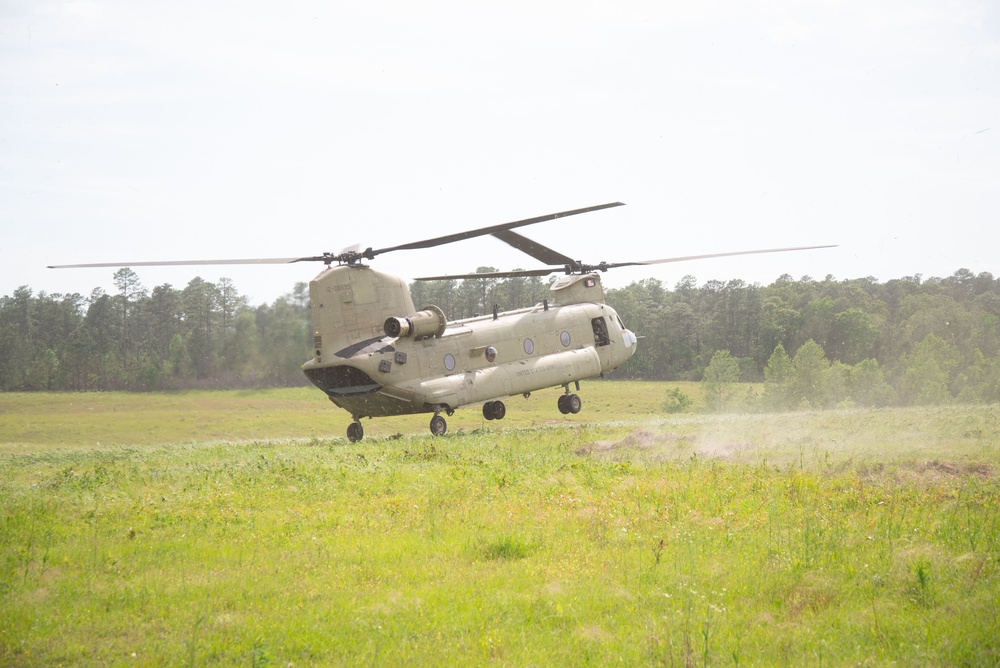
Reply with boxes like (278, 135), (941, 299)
(0, 268), (312, 391)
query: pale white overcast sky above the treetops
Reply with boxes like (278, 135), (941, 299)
(0, 0), (1000, 304)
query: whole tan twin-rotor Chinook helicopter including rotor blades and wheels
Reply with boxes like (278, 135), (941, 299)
(51, 202), (830, 442)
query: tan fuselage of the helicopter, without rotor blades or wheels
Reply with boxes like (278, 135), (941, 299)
(302, 265), (636, 419)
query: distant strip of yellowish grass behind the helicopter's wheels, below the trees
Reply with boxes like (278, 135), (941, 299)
(0, 382), (680, 452)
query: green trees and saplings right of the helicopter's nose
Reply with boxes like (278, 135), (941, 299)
(607, 269), (1000, 408)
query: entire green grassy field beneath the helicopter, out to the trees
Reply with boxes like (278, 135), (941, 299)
(0, 382), (1000, 666)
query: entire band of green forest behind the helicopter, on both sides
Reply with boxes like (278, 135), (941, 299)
(0, 267), (1000, 408)
